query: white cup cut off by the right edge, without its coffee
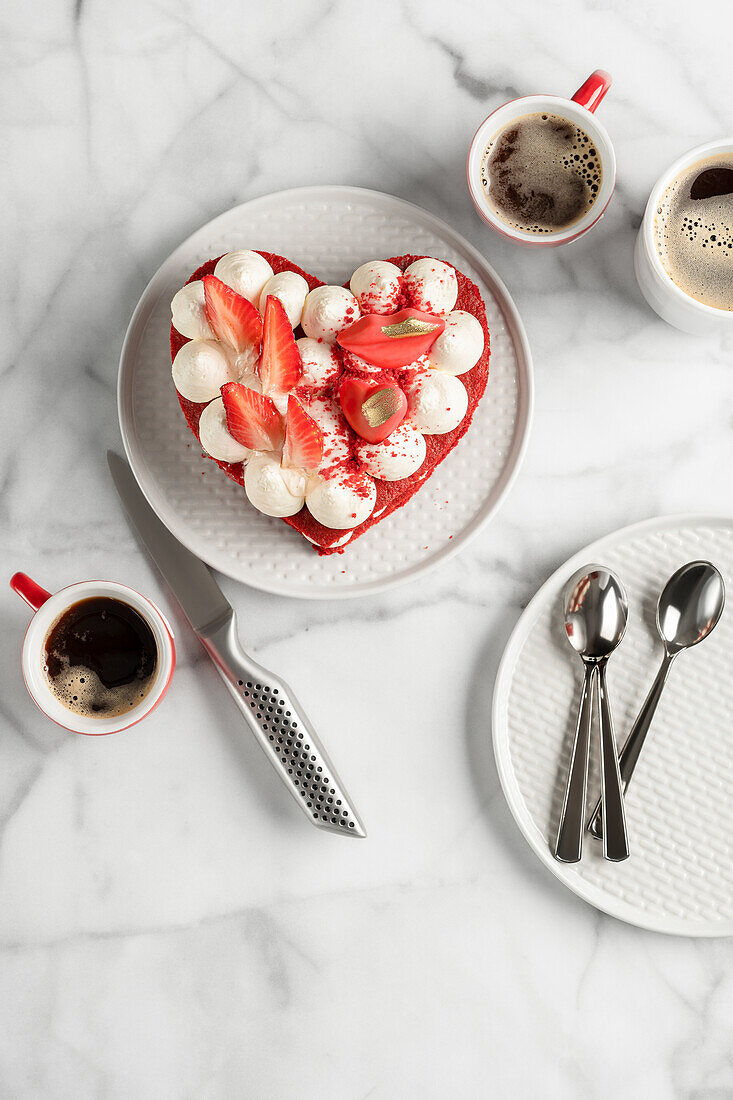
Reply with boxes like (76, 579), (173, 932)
(634, 138), (733, 336)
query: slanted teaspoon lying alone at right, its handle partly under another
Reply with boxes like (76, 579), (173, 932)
(588, 561), (725, 839)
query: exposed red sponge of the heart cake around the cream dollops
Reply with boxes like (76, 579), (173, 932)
(171, 249), (491, 554)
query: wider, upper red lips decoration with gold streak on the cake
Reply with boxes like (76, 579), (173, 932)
(338, 307), (446, 371)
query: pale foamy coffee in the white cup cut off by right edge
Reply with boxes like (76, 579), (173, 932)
(654, 153), (733, 310)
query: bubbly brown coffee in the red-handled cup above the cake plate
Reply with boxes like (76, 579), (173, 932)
(481, 114), (603, 233)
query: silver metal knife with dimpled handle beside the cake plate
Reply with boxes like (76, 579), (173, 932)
(107, 451), (367, 836)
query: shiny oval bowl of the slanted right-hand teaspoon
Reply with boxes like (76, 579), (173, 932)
(657, 561), (725, 656)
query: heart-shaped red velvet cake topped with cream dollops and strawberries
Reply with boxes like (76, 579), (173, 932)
(171, 251), (490, 554)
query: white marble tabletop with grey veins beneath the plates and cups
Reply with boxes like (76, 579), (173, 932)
(0, 0), (733, 1100)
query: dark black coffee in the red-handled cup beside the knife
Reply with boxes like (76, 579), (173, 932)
(44, 596), (157, 718)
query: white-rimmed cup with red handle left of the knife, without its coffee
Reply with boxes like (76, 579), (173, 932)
(10, 573), (176, 737)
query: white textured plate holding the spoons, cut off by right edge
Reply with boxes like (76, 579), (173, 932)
(493, 516), (733, 936)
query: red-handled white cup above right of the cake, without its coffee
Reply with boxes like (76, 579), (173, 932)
(466, 69), (616, 249)
